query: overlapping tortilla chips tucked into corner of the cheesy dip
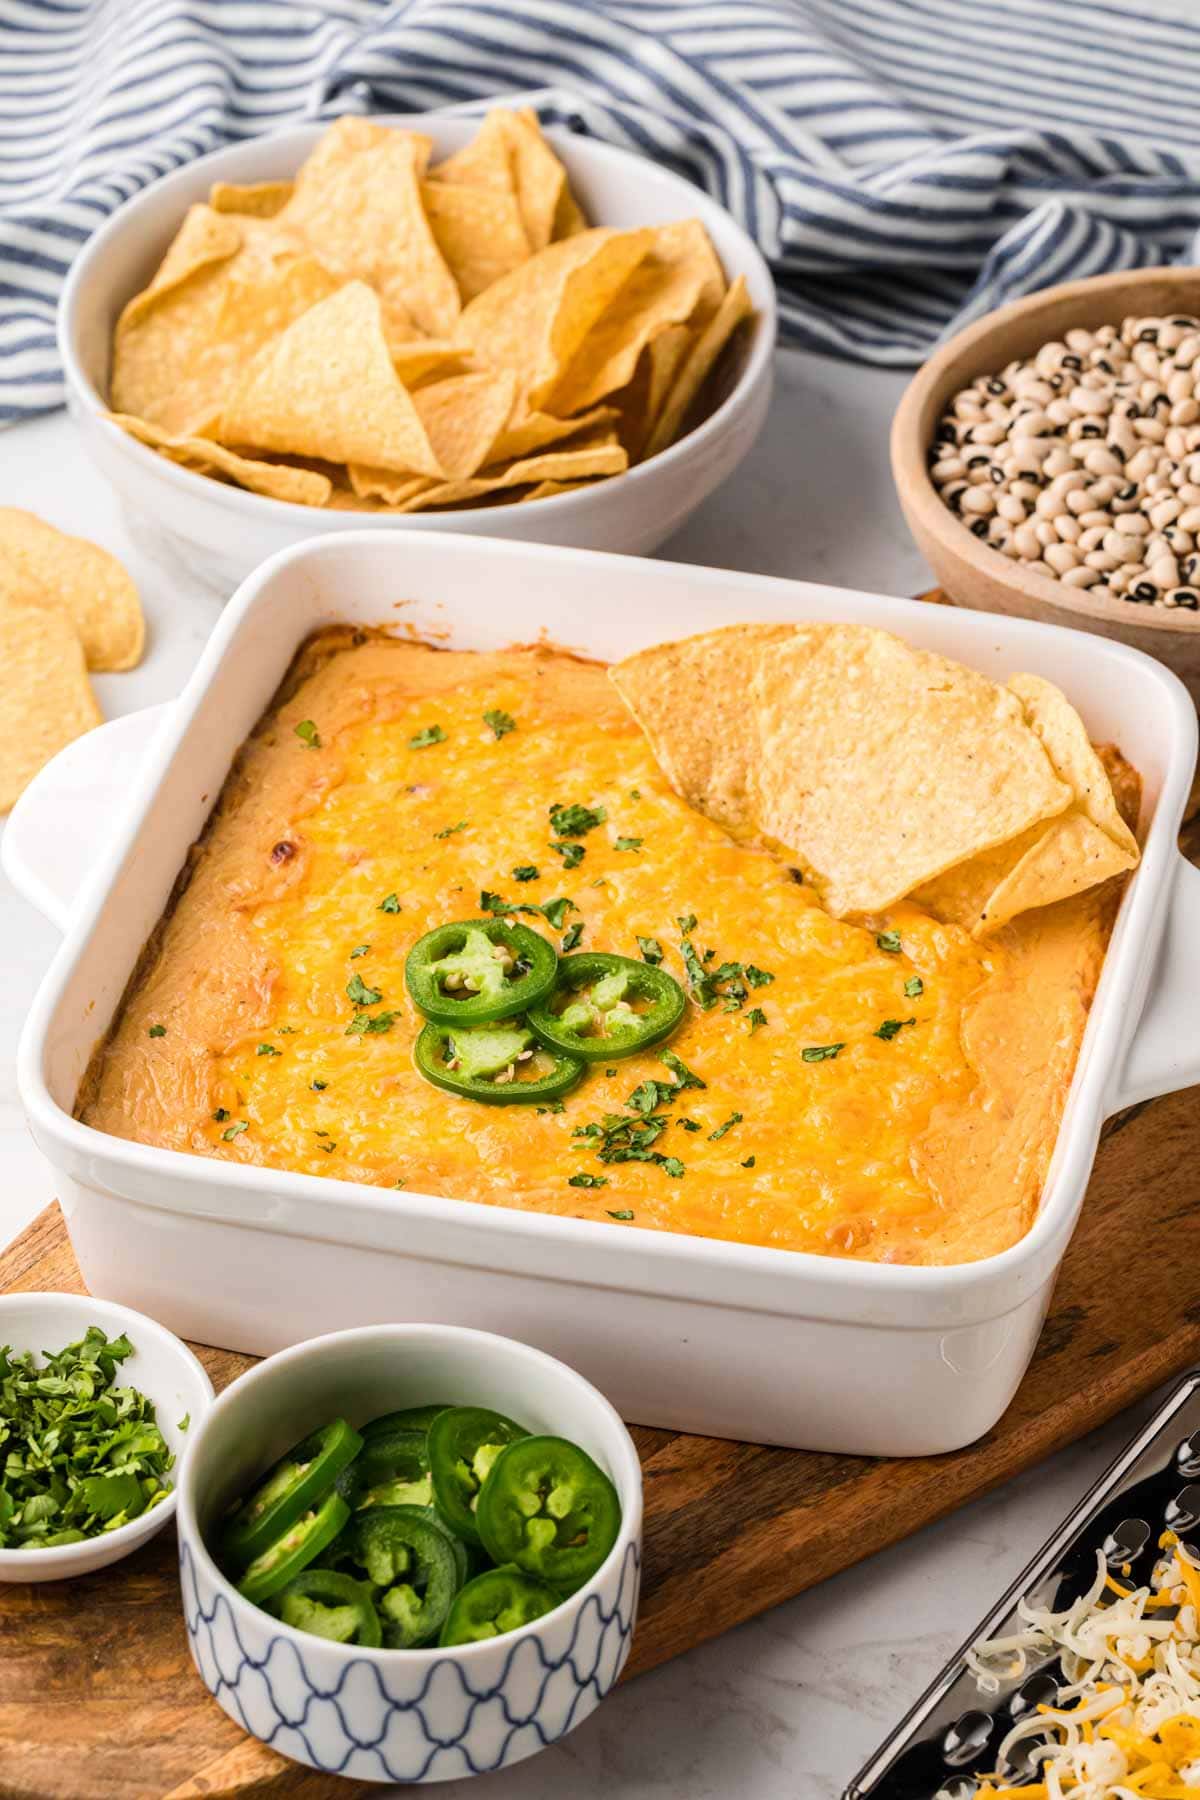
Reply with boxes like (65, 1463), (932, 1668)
(612, 625), (1137, 936)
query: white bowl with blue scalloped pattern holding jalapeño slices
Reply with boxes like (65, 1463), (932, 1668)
(178, 1325), (642, 1782)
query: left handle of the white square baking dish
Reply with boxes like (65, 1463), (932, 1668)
(0, 704), (167, 931)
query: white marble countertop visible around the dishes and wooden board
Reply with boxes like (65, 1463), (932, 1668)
(0, 355), (1173, 1800)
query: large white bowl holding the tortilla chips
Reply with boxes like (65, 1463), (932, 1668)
(58, 113), (775, 589)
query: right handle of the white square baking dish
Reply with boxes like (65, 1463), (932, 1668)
(1108, 857), (1200, 1112)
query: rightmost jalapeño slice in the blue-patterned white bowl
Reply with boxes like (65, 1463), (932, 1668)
(475, 1438), (621, 1593)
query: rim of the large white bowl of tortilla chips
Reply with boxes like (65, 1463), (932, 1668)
(58, 108), (775, 529)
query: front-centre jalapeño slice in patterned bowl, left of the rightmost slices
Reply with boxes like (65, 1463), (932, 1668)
(354, 1507), (462, 1651)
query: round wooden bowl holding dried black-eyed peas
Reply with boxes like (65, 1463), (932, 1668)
(892, 268), (1200, 702)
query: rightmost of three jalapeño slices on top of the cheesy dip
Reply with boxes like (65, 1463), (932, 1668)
(525, 950), (687, 1062)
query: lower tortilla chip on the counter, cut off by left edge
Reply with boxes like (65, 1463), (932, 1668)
(0, 594), (103, 812)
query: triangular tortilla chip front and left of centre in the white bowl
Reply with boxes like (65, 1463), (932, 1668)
(219, 281), (443, 475)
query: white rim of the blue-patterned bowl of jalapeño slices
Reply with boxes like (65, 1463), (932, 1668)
(177, 1314), (642, 1669)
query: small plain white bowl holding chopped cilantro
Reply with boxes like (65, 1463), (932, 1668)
(0, 1294), (212, 1580)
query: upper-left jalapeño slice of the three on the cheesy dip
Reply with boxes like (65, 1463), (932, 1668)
(405, 918), (558, 1026)
